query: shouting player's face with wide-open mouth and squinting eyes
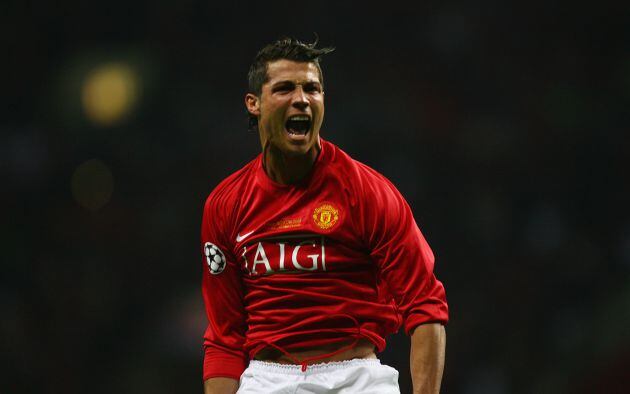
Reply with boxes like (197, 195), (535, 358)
(245, 60), (324, 157)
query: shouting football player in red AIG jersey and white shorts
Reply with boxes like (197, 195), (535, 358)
(202, 39), (448, 394)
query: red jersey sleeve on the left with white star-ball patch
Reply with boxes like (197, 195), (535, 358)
(201, 194), (247, 381)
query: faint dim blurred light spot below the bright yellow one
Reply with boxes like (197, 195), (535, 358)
(71, 159), (114, 211)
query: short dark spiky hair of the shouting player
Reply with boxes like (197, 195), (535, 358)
(247, 35), (335, 130)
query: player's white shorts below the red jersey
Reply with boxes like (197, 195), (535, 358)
(237, 358), (400, 394)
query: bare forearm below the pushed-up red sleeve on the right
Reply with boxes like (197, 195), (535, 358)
(409, 323), (446, 394)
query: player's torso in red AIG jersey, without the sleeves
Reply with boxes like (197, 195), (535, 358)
(209, 139), (420, 364)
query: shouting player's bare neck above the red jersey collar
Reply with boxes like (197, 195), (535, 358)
(263, 145), (321, 185)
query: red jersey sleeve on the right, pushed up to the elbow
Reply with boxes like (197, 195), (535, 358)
(361, 172), (448, 333)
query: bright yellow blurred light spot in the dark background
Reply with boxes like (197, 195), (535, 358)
(81, 63), (139, 126)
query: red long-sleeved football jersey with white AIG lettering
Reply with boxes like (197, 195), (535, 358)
(201, 140), (448, 380)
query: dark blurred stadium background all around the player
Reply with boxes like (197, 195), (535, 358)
(0, 0), (630, 394)
